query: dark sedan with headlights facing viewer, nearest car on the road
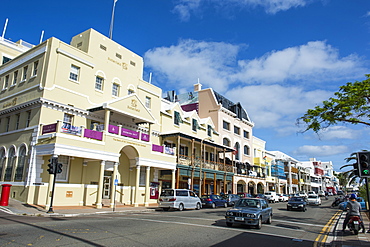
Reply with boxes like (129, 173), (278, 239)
(225, 198), (272, 229)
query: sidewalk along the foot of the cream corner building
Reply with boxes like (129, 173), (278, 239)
(0, 198), (158, 217)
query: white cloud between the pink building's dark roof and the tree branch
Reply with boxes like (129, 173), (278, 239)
(226, 84), (332, 128)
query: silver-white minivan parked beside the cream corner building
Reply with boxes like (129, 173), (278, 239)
(158, 189), (202, 211)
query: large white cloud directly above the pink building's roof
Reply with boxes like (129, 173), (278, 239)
(145, 40), (243, 91)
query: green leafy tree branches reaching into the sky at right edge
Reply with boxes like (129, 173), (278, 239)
(297, 74), (370, 133)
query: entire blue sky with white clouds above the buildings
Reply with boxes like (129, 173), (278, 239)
(0, 0), (370, 171)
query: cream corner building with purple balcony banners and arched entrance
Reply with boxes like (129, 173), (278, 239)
(0, 29), (182, 208)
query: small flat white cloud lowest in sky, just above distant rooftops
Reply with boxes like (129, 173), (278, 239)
(293, 145), (349, 157)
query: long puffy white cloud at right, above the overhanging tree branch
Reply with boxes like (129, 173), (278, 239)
(233, 41), (365, 83)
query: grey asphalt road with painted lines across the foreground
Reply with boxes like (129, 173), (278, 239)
(0, 201), (338, 246)
